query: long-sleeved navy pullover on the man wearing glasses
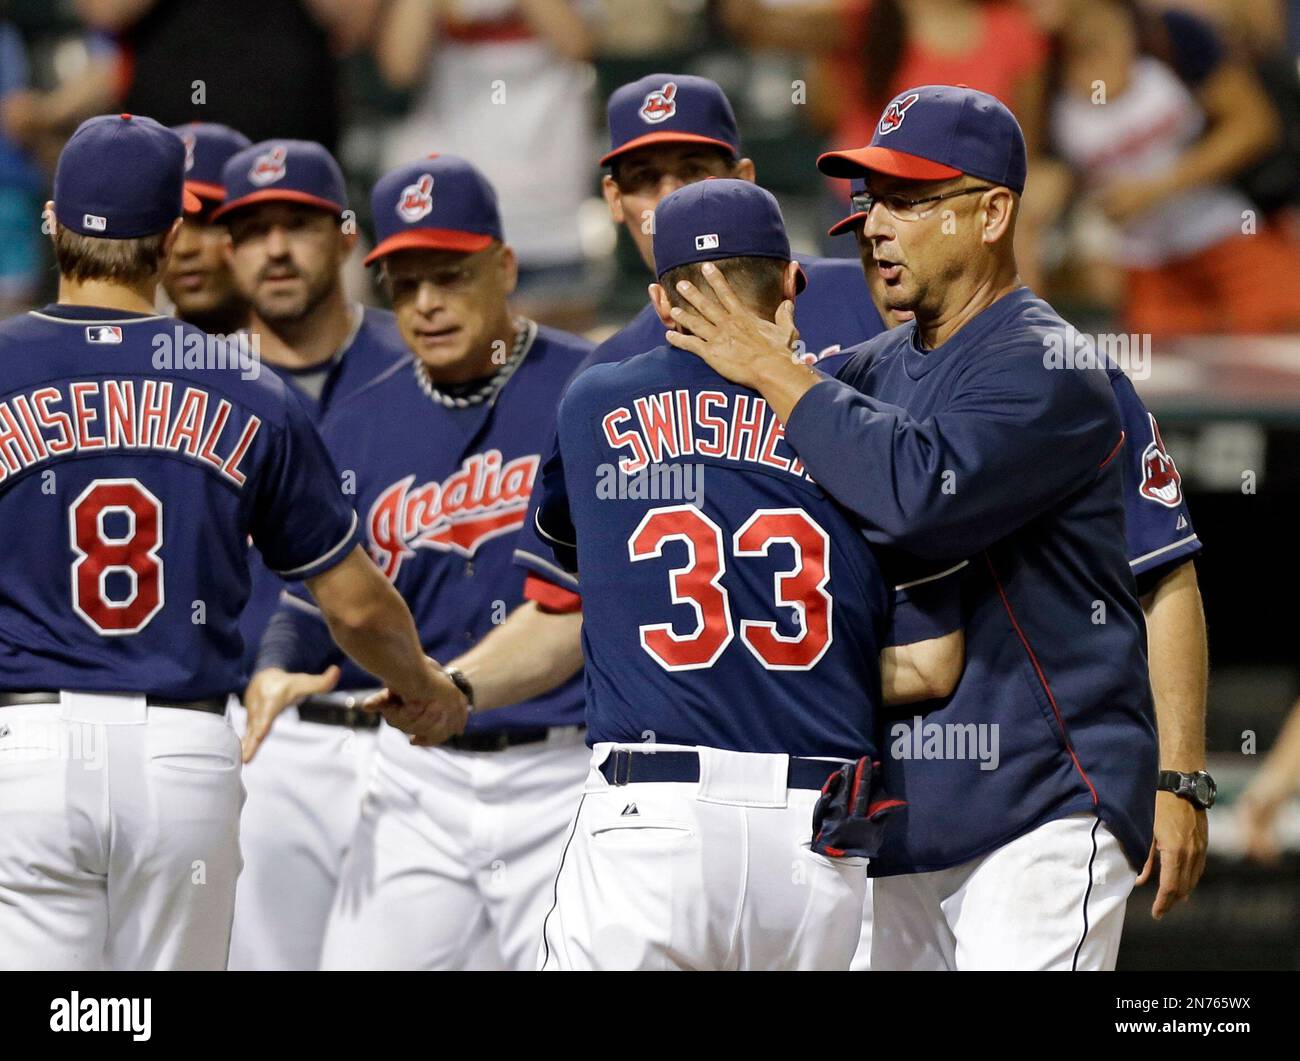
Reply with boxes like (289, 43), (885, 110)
(787, 287), (1157, 874)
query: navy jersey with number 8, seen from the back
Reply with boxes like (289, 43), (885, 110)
(0, 306), (356, 700)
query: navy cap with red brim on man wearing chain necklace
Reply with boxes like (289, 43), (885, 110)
(365, 155), (504, 265)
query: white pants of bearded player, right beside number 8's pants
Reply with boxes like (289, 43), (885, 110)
(230, 706), (378, 970)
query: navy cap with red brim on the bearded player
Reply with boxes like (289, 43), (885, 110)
(212, 140), (347, 218)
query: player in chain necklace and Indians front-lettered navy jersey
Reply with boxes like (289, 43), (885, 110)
(255, 155), (592, 969)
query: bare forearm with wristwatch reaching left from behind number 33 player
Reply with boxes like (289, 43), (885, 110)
(451, 601), (582, 711)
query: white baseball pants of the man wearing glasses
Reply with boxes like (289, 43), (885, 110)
(871, 814), (1138, 971)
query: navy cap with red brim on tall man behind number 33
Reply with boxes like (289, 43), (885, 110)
(601, 74), (740, 165)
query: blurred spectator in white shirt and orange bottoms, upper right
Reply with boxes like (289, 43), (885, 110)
(1032, 0), (1300, 335)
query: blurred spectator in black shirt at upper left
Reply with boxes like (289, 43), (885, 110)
(77, 0), (381, 151)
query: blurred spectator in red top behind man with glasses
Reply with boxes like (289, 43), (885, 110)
(722, 0), (1047, 289)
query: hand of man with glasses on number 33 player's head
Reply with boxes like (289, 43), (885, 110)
(668, 263), (822, 421)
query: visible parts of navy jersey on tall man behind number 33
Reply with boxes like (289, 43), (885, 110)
(515, 257), (884, 589)
